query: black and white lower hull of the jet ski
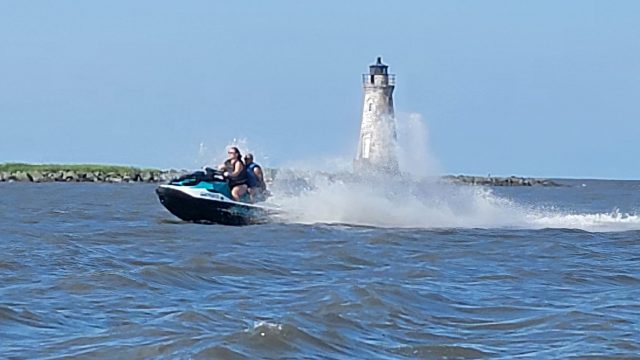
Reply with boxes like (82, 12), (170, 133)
(156, 185), (274, 225)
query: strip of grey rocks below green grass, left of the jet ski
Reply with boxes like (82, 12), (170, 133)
(0, 170), (184, 183)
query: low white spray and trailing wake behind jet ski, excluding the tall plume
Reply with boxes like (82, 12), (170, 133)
(274, 174), (640, 231)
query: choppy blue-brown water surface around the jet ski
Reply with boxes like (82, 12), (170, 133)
(0, 182), (640, 359)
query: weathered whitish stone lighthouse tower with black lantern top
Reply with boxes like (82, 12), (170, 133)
(353, 57), (398, 173)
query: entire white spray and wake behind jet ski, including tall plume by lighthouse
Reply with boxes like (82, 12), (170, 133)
(272, 114), (640, 231)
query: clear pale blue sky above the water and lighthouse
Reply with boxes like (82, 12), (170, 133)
(0, 0), (640, 179)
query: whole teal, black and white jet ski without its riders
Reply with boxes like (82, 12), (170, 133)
(156, 168), (279, 225)
